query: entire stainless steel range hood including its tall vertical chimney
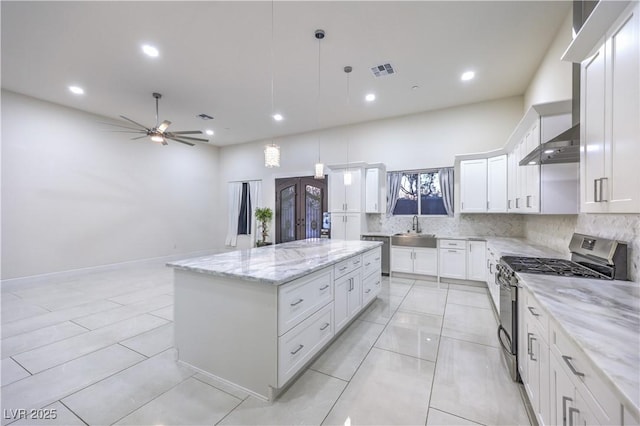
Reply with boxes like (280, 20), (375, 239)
(520, 0), (598, 166)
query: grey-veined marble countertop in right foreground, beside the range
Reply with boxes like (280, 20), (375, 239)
(518, 273), (640, 412)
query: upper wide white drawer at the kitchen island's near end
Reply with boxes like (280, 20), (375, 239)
(278, 267), (333, 336)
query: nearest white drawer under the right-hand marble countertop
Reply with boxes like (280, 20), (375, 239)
(549, 321), (621, 424)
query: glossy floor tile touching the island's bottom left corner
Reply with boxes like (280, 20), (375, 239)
(62, 351), (194, 425)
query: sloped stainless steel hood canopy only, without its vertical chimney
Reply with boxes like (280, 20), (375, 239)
(520, 124), (580, 166)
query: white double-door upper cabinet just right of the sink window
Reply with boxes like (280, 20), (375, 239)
(460, 155), (507, 213)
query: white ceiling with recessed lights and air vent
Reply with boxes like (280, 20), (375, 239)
(1, 1), (571, 146)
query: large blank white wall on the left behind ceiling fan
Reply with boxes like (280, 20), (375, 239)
(2, 91), (220, 279)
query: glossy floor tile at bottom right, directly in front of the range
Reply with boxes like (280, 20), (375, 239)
(431, 337), (529, 425)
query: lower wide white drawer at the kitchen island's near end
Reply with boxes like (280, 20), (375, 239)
(278, 303), (334, 388)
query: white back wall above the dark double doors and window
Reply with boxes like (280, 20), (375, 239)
(218, 97), (522, 243)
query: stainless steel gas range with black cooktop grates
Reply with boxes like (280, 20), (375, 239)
(496, 234), (627, 381)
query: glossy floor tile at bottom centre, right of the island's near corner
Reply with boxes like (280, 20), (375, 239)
(323, 348), (435, 425)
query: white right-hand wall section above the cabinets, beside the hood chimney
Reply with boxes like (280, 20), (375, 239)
(524, 10), (573, 112)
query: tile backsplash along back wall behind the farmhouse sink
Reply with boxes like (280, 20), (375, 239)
(367, 214), (524, 237)
